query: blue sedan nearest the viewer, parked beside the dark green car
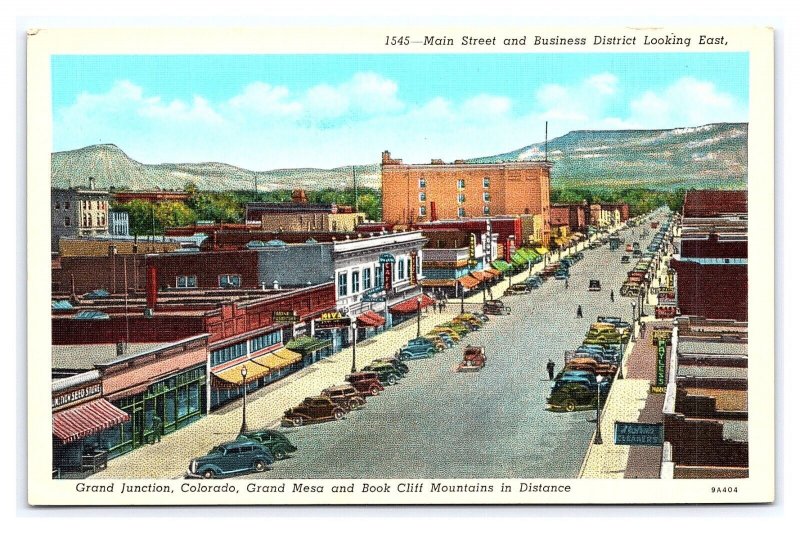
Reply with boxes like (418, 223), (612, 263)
(186, 440), (275, 479)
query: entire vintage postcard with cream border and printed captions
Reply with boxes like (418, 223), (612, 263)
(27, 24), (775, 506)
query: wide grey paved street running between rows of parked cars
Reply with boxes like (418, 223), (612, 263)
(245, 211), (664, 479)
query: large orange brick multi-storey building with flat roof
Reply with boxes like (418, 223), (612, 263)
(381, 151), (552, 242)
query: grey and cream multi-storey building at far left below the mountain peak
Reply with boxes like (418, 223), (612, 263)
(50, 182), (110, 252)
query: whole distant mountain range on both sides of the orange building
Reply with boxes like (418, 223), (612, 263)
(51, 123), (747, 191)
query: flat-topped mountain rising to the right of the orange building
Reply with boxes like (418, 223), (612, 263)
(467, 123), (747, 189)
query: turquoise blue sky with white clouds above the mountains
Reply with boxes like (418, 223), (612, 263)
(52, 53), (748, 170)
